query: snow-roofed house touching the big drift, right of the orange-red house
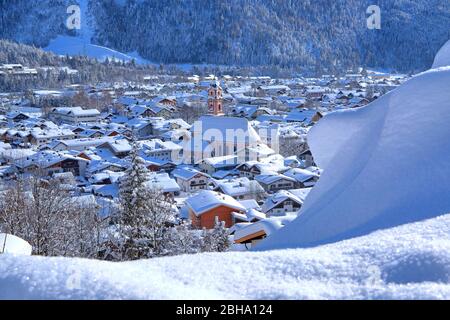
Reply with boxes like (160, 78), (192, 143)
(261, 189), (311, 217)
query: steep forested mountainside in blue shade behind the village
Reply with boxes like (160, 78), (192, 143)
(0, 0), (450, 71)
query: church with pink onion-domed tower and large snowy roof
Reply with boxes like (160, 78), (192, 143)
(184, 80), (275, 164)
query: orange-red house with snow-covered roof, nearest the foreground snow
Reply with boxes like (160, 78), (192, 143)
(186, 190), (245, 229)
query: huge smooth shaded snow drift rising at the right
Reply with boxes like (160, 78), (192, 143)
(257, 39), (450, 250)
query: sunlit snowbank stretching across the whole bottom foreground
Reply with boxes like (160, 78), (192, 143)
(0, 215), (450, 299)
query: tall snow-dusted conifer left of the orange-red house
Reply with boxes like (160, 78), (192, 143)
(103, 142), (173, 260)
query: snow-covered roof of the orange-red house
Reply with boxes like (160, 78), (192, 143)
(186, 190), (245, 216)
